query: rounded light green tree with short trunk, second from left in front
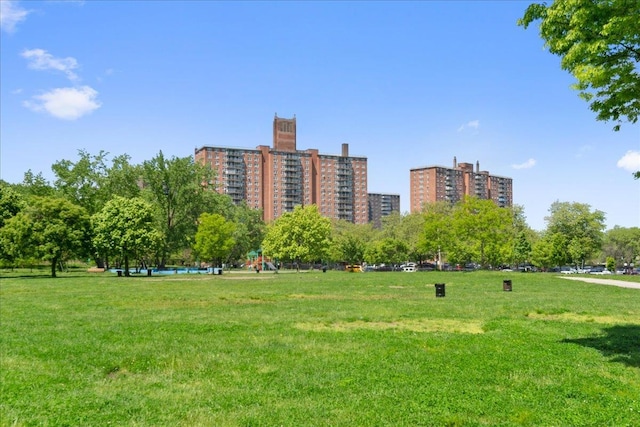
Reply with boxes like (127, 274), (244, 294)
(91, 196), (160, 276)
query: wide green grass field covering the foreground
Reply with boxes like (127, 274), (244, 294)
(0, 271), (640, 427)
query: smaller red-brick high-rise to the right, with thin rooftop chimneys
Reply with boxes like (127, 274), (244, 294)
(410, 157), (513, 212)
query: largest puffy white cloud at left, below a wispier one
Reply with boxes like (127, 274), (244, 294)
(23, 86), (102, 120)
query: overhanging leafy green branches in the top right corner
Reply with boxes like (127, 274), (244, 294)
(518, 0), (640, 135)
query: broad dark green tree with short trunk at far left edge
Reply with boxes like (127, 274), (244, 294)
(2, 197), (90, 277)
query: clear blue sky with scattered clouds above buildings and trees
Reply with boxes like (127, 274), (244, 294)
(0, 0), (640, 230)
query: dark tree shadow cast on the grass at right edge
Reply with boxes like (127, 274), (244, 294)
(562, 325), (640, 368)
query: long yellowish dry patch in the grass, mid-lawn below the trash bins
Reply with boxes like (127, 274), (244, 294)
(295, 319), (484, 334)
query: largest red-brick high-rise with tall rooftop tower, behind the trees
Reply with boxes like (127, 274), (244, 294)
(195, 115), (369, 224)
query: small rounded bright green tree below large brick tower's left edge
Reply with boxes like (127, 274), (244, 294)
(193, 212), (236, 265)
